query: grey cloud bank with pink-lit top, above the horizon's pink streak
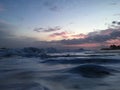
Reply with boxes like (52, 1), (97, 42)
(49, 22), (120, 47)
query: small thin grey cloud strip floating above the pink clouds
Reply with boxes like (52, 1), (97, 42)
(33, 26), (61, 32)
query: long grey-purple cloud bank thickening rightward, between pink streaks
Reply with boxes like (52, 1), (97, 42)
(60, 29), (120, 45)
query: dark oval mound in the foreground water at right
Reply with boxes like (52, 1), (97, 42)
(70, 64), (115, 78)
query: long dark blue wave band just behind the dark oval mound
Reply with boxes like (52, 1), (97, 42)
(40, 58), (120, 64)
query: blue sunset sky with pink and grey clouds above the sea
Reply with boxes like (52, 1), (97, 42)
(0, 0), (120, 48)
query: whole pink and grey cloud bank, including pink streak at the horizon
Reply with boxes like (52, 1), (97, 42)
(49, 22), (120, 48)
